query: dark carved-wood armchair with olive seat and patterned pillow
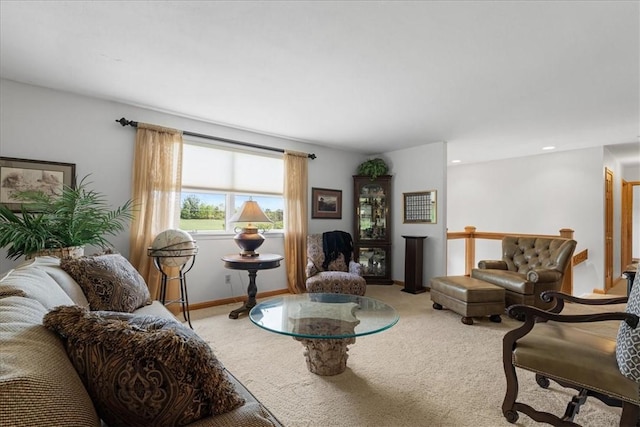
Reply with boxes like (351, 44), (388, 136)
(502, 264), (640, 426)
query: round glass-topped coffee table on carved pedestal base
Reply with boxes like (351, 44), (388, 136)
(249, 293), (399, 375)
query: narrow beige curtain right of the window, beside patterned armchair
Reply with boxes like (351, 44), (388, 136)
(284, 151), (308, 294)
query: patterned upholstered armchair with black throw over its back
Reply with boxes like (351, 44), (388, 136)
(306, 231), (367, 295)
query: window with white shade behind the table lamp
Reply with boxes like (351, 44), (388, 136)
(180, 142), (284, 232)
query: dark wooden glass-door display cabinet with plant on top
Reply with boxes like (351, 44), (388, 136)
(353, 175), (393, 285)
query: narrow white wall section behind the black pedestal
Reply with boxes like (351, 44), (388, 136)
(383, 142), (447, 286)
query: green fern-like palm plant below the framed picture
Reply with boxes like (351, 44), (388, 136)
(0, 175), (133, 259)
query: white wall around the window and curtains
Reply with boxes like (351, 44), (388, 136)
(0, 80), (365, 303)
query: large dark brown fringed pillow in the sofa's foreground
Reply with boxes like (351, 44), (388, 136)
(43, 306), (244, 427)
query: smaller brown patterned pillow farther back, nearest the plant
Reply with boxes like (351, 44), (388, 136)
(60, 254), (151, 313)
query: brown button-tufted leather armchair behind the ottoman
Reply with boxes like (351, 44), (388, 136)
(471, 236), (576, 309)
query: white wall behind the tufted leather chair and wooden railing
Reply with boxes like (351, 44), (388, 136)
(447, 148), (604, 295)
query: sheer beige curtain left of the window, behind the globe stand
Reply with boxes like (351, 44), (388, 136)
(129, 123), (182, 299)
